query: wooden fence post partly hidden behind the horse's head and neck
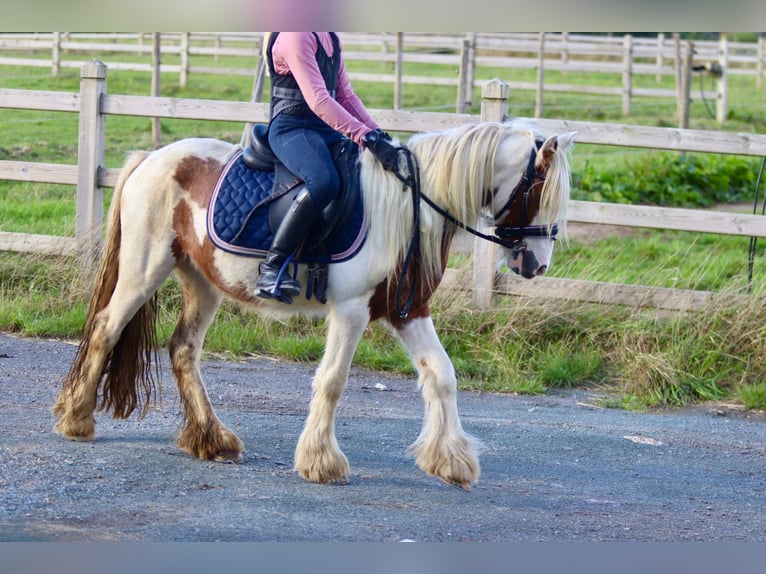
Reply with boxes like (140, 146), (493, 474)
(473, 78), (510, 309)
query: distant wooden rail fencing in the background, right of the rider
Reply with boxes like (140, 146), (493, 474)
(343, 33), (764, 127)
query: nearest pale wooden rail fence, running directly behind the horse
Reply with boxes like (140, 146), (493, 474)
(0, 61), (766, 316)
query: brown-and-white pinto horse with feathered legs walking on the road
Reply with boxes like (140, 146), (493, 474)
(52, 120), (574, 490)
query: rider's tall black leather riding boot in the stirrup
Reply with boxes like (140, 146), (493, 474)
(255, 189), (320, 303)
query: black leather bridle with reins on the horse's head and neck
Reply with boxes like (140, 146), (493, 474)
(393, 140), (559, 319)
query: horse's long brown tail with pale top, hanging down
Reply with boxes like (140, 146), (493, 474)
(64, 152), (158, 418)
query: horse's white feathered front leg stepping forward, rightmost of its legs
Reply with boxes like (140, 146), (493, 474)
(397, 316), (480, 490)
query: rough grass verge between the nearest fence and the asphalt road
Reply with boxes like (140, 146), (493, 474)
(0, 216), (766, 414)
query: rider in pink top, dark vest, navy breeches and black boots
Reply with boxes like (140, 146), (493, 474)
(255, 32), (398, 303)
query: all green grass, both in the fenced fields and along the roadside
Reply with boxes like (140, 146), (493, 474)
(0, 42), (766, 409)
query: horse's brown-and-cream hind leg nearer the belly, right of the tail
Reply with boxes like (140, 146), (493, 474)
(168, 262), (244, 461)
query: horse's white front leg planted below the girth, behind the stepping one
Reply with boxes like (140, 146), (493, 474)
(295, 300), (369, 484)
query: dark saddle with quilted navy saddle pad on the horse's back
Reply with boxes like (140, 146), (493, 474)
(208, 124), (367, 302)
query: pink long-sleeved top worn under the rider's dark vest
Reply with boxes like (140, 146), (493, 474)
(271, 32), (378, 144)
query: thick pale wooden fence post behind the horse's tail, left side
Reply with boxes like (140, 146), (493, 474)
(75, 60), (106, 261)
